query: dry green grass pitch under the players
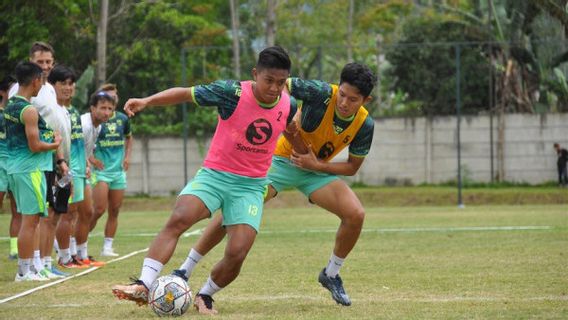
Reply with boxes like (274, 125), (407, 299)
(0, 190), (568, 319)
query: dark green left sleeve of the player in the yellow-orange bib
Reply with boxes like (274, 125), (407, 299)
(288, 78), (331, 106)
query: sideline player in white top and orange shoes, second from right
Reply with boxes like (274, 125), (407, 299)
(58, 91), (115, 268)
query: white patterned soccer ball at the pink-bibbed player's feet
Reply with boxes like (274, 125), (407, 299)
(148, 275), (191, 317)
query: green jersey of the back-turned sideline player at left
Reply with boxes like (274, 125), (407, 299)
(4, 96), (53, 174)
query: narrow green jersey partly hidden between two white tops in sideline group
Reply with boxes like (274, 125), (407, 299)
(68, 106), (87, 178)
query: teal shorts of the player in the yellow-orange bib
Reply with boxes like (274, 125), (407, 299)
(268, 156), (339, 198)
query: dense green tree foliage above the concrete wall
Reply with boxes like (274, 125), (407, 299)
(0, 0), (568, 136)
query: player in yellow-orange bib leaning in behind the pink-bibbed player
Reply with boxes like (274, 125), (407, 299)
(180, 63), (376, 306)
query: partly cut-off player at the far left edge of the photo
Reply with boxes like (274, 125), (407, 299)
(0, 76), (22, 260)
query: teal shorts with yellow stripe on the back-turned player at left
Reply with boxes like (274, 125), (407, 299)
(8, 169), (47, 217)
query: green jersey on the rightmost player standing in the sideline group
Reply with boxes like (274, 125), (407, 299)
(95, 112), (132, 172)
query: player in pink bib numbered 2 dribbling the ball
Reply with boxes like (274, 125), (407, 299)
(113, 46), (302, 314)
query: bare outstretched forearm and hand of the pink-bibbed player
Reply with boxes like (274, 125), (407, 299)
(124, 88), (193, 117)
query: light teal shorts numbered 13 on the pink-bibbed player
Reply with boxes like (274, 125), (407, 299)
(179, 168), (268, 232)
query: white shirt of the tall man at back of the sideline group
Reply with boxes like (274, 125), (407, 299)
(8, 83), (71, 163)
